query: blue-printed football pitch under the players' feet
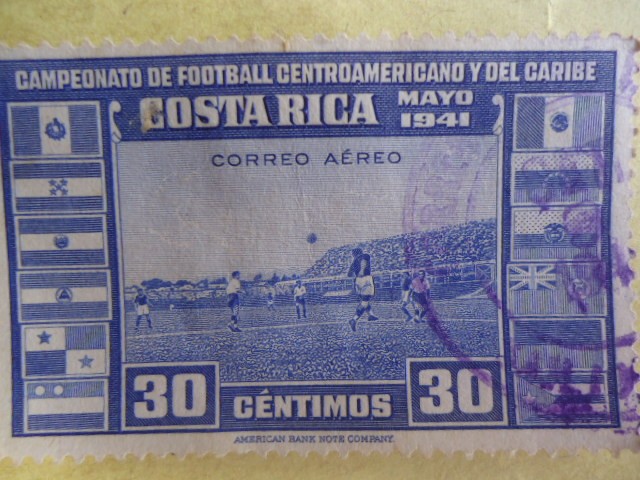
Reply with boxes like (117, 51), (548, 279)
(125, 298), (500, 382)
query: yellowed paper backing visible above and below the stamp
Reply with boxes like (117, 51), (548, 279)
(0, 0), (640, 480)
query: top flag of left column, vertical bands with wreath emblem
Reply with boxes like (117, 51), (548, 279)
(9, 102), (102, 158)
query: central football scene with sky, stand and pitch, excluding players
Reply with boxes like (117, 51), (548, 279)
(118, 136), (500, 381)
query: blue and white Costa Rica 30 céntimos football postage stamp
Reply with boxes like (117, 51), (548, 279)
(0, 37), (640, 458)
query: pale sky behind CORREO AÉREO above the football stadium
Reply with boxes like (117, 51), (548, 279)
(118, 137), (498, 285)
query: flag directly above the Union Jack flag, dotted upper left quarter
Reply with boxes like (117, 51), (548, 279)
(511, 208), (600, 260)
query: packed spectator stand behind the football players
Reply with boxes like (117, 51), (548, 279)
(304, 219), (496, 277)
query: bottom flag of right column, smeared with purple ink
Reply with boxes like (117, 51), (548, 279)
(516, 368), (612, 426)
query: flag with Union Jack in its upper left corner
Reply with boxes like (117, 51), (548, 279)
(507, 263), (607, 317)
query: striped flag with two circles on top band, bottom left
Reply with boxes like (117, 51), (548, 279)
(25, 380), (107, 432)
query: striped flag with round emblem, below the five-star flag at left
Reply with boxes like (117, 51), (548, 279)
(18, 217), (106, 267)
